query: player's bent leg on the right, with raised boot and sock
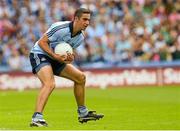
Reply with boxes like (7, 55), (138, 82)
(60, 64), (104, 123)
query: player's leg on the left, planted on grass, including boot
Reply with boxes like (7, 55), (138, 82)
(31, 65), (55, 126)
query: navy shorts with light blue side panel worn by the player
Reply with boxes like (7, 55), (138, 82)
(29, 53), (66, 76)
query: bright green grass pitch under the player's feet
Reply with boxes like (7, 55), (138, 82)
(0, 86), (180, 130)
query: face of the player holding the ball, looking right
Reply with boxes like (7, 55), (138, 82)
(76, 13), (90, 30)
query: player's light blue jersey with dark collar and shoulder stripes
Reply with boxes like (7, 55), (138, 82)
(30, 21), (84, 56)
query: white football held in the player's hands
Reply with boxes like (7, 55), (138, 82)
(54, 42), (73, 55)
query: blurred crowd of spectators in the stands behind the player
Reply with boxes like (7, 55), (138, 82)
(0, 0), (180, 71)
